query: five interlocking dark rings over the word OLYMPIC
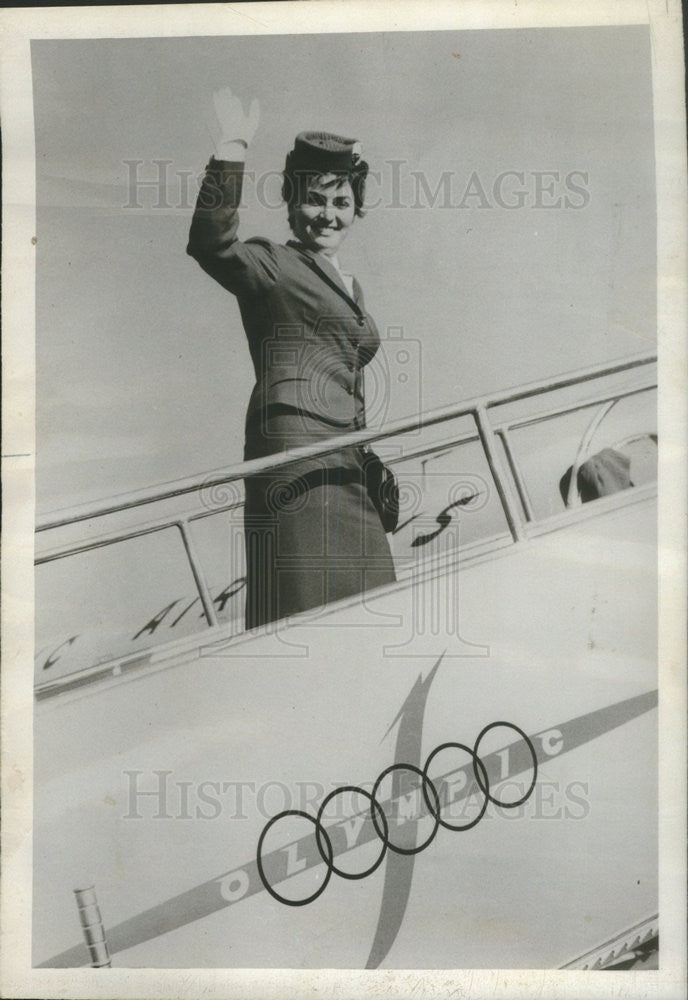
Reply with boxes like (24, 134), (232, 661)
(256, 722), (538, 906)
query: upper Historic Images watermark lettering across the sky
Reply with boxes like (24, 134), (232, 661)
(122, 158), (592, 212)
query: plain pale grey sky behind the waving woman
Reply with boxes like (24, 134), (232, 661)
(32, 26), (656, 514)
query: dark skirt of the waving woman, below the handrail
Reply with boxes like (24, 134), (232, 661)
(244, 456), (395, 629)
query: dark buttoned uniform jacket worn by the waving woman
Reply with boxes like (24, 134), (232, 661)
(187, 158), (380, 465)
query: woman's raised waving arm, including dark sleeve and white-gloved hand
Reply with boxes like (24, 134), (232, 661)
(186, 87), (271, 295)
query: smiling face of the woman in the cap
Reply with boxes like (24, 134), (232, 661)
(292, 174), (356, 257)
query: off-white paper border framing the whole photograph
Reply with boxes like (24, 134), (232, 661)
(0, 0), (688, 1000)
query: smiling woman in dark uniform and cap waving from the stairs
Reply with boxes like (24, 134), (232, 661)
(187, 88), (395, 628)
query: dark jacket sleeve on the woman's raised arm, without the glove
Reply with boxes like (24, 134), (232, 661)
(186, 157), (277, 296)
